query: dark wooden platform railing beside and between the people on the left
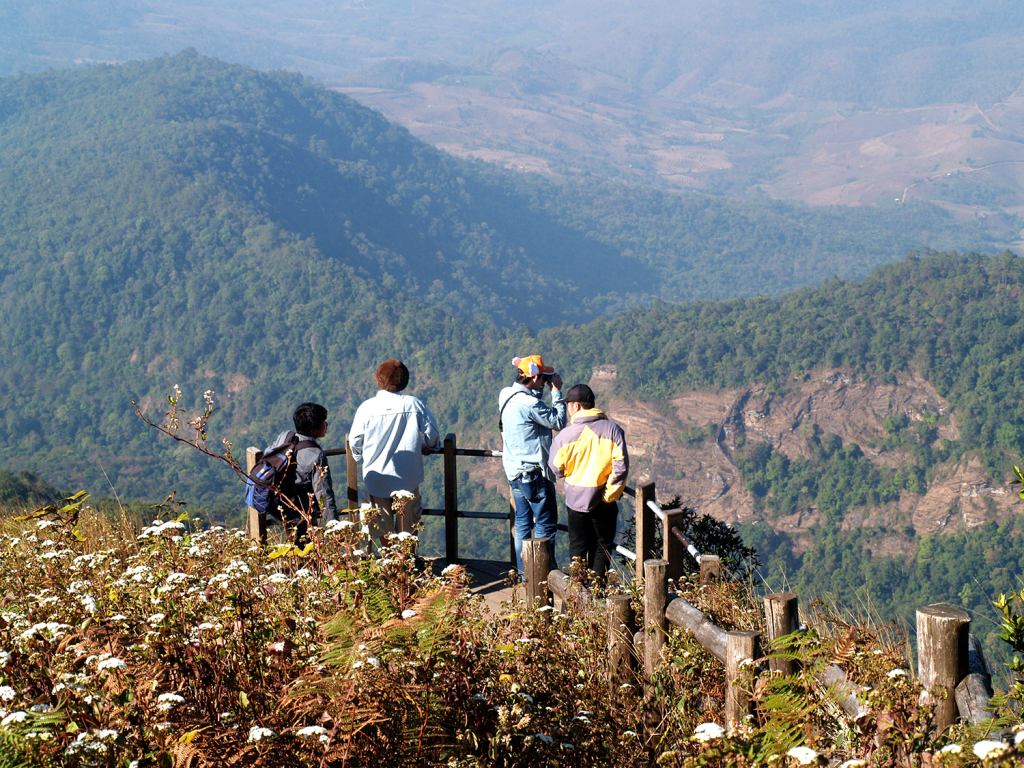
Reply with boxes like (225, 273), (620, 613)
(246, 433), (516, 563)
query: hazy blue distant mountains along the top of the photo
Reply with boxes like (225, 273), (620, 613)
(0, 0), (1024, 108)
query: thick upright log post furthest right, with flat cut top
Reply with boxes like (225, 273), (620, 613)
(918, 605), (971, 733)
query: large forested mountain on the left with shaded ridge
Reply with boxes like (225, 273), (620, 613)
(0, 52), (991, 512)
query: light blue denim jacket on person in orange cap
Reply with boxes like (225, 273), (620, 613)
(498, 383), (566, 481)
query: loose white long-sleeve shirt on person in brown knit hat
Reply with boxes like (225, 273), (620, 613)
(348, 389), (440, 498)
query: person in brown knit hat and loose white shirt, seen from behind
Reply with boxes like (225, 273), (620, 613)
(348, 359), (440, 544)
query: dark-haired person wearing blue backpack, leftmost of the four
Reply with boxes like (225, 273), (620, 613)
(246, 402), (338, 544)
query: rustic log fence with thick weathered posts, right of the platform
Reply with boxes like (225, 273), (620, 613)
(523, 483), (992, 732)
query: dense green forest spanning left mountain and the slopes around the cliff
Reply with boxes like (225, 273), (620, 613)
(6, 53), (1024, 651)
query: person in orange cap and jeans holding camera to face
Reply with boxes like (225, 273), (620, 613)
(498, 354), (566, 575)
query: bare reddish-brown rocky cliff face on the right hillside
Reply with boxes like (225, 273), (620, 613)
(591, 366), (1022, 553)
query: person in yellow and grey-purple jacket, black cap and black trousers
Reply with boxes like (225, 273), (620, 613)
(548, 384), (630, 582)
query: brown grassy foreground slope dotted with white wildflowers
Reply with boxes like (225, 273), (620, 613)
(0, 505), (1016, 768)
